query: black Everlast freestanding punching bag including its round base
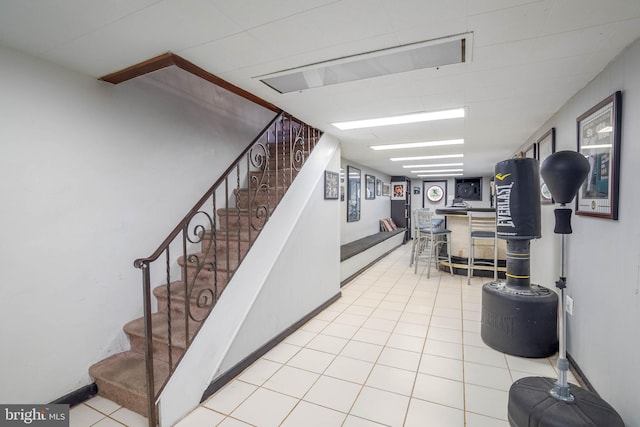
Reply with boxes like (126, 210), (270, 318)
(480, 158), (558, 357)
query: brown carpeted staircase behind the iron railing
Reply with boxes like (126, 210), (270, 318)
(89, 118), (318, 417)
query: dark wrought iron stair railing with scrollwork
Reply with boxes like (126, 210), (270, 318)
(134, 113), (321, 427)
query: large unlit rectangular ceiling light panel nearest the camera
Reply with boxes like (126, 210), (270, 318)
(257, 33), (472, 93)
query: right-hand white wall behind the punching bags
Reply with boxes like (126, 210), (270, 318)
(523, 41), (640, 427)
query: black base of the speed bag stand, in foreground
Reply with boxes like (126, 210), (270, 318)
(508, 377), (624, 427)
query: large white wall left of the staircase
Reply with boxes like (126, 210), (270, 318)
(0, 48), (273, 403)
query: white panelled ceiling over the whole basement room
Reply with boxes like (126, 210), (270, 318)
(0, 0), (640, 176)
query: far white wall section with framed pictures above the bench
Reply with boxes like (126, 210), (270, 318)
(340, 159), (391, 245)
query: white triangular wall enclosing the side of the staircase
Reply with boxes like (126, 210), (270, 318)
(160, 135), (340, 426)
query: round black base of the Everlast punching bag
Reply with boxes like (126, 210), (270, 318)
(480, 282), (558, 358)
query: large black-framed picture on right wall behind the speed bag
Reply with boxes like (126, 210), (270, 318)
(576, 91), (622, 220)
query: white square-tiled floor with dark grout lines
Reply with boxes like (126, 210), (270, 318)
(70, 245), (577, 427)
